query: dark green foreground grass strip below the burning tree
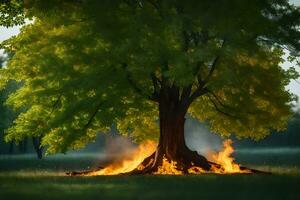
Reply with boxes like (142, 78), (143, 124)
(0, 172), (300, 200)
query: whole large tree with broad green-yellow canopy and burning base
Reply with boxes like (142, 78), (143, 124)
(1, 0), (300, 173)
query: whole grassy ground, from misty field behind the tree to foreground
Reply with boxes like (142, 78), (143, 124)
(0, 151), (300, 200)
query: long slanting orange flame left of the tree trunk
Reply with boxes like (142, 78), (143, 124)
(88, 140), (156, 176)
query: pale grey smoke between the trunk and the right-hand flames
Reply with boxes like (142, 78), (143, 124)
(185, 118), (222, 156)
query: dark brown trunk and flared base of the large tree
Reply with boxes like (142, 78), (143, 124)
(134, 94), (211, 173)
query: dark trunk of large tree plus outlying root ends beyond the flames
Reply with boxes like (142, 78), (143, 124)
(67, 87), (264, 176)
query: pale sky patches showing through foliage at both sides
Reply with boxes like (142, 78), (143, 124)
(0, 0), (300, 97)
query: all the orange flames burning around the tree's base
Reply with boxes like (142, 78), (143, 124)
(88, 140), (251, 176)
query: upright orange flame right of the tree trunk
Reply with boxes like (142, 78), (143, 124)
(211, 139), (250, 173)
